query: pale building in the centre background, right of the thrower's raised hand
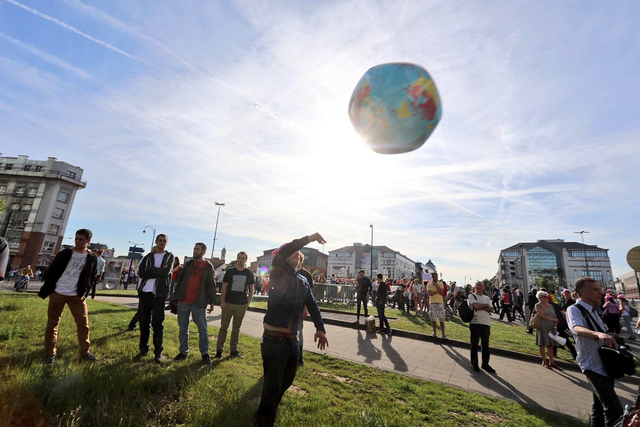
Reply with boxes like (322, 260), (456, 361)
(327, 243), (416, 280)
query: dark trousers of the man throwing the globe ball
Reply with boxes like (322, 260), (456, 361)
(254, 336), (298, 426)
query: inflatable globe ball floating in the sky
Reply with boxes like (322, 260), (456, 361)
(349, 63), (442, 154)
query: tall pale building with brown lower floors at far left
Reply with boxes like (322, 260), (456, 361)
(0, 153), (87, 270)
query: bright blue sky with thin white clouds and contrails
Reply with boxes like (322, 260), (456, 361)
(0, 0), (640, 283)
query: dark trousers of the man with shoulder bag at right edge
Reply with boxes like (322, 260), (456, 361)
(584, 371), (622, 427)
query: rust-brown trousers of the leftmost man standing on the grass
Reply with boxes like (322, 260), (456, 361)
(44, 292), (91, 357)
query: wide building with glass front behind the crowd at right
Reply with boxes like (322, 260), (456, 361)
(496, 239), (614, 292)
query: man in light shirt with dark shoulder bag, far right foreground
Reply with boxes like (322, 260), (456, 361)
(567, 277), (623, 426)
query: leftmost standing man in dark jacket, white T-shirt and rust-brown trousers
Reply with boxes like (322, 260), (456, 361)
(38, 228), (98, 366)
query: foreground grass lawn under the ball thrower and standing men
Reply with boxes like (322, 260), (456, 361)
(0, 293), (583, 427)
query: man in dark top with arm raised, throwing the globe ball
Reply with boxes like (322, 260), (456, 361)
(254, 233), (328, 427)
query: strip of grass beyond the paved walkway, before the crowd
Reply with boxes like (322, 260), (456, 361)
(251, 301), (575, 363)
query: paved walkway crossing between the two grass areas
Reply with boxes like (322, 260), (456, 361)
(96, 296), (637, 420)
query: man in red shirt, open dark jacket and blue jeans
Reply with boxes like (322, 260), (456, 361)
(171, 242), (216, 366)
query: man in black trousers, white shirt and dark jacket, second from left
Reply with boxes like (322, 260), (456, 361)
(132, 234), (173, 363)
